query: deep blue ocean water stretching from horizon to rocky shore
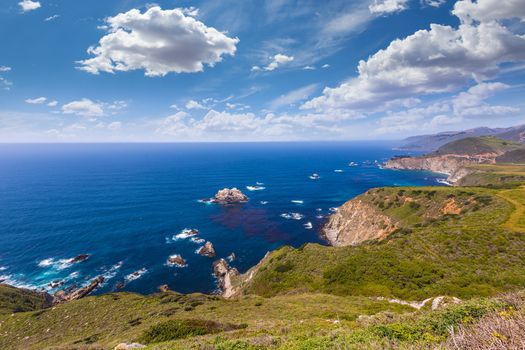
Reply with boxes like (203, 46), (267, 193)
(0, 142), (438, 293)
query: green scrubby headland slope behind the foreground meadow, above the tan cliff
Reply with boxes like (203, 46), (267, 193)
(247, 188), (525, 300)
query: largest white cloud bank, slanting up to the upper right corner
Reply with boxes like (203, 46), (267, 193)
(303, 0), (525, 111)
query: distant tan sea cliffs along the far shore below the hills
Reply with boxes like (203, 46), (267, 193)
(384, 154), (488, 184)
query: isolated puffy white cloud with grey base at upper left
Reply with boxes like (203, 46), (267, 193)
(78, 6), (239, 77)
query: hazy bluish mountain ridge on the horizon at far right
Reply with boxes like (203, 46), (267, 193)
(396, 125), (525, 152)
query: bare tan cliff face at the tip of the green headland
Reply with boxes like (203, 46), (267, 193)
(323, 197), (399, 247)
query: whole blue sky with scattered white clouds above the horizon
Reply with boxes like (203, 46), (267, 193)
(0, 0), (525, 142)
